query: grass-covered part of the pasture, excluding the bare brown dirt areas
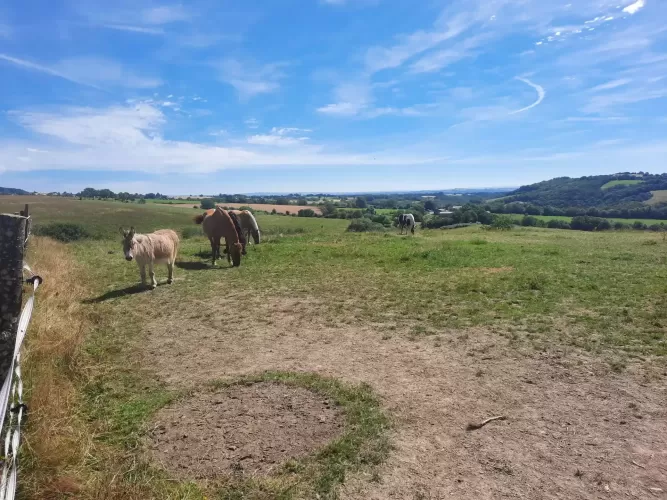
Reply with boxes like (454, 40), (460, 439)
(0, 197), (667, 499)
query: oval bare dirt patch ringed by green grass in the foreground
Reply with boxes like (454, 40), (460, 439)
(148, 383), (344, 479)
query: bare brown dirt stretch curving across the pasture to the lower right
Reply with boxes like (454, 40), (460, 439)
(142, 298), (667, 500)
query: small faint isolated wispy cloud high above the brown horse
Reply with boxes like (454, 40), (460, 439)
(218, 59), (287, 99)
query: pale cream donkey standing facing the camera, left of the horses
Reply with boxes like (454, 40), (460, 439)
(120, 227), (179, 288)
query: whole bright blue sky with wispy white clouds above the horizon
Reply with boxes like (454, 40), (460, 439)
(0, 0), (667, 194)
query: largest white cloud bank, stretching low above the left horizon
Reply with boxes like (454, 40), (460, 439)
(0, 104), (446, 173)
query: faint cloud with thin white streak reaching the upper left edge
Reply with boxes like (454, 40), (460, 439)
(0, 54), (162, 89)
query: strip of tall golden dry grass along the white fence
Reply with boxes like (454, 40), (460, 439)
(21, 238), (92, 499)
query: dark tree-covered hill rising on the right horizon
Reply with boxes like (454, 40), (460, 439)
(495, 173), (667, 209)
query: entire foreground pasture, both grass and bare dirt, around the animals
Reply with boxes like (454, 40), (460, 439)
(0, 196), (667, 500)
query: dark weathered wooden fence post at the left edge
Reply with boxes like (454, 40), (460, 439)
(0, 214), (28, 384)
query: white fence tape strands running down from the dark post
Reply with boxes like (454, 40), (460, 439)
(0, 219), (42, 500)
